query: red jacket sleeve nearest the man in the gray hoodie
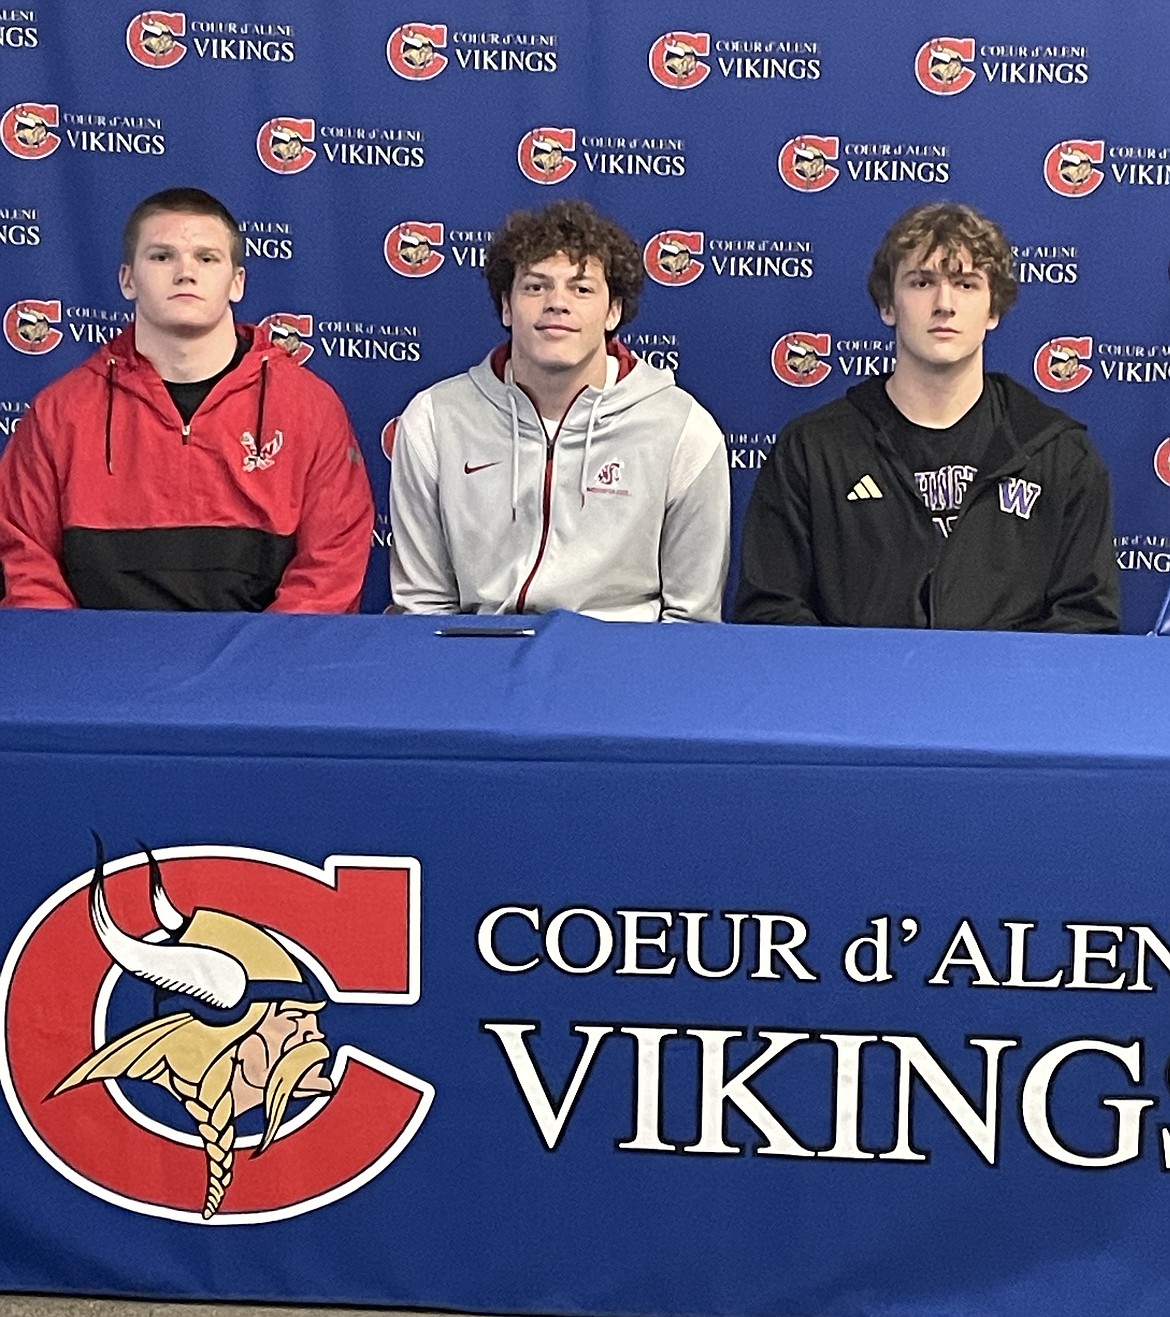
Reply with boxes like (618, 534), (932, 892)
(270, 386), (374, 612)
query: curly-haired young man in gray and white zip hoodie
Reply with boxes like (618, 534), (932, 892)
(390, 202), (730, 622)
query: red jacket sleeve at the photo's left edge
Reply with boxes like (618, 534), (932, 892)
(0, 407), (78, 608)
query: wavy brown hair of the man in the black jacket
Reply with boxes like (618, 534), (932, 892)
(867, 202), (1020, 316)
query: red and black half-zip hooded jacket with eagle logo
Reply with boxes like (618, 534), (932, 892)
(0, 327), (373, 612)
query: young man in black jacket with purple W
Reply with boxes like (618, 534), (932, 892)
(735, 203), (1119, 631)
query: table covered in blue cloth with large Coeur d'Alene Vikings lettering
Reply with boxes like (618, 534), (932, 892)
(0, 612), (1170, 1317)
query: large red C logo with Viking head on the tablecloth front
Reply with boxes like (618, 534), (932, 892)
(0, 840), (433, 1225)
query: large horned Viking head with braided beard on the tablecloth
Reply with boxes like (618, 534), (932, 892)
(53, 838), (332, 1220)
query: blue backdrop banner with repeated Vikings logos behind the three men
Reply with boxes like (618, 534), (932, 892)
(0, 0), (1170, 632)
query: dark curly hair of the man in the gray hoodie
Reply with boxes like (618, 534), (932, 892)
(484, 202), (646, 337)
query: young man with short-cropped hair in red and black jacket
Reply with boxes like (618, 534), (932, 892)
(0, 188), (373, 612)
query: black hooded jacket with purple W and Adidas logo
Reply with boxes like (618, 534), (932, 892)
(735, 374), (1120, 631)
